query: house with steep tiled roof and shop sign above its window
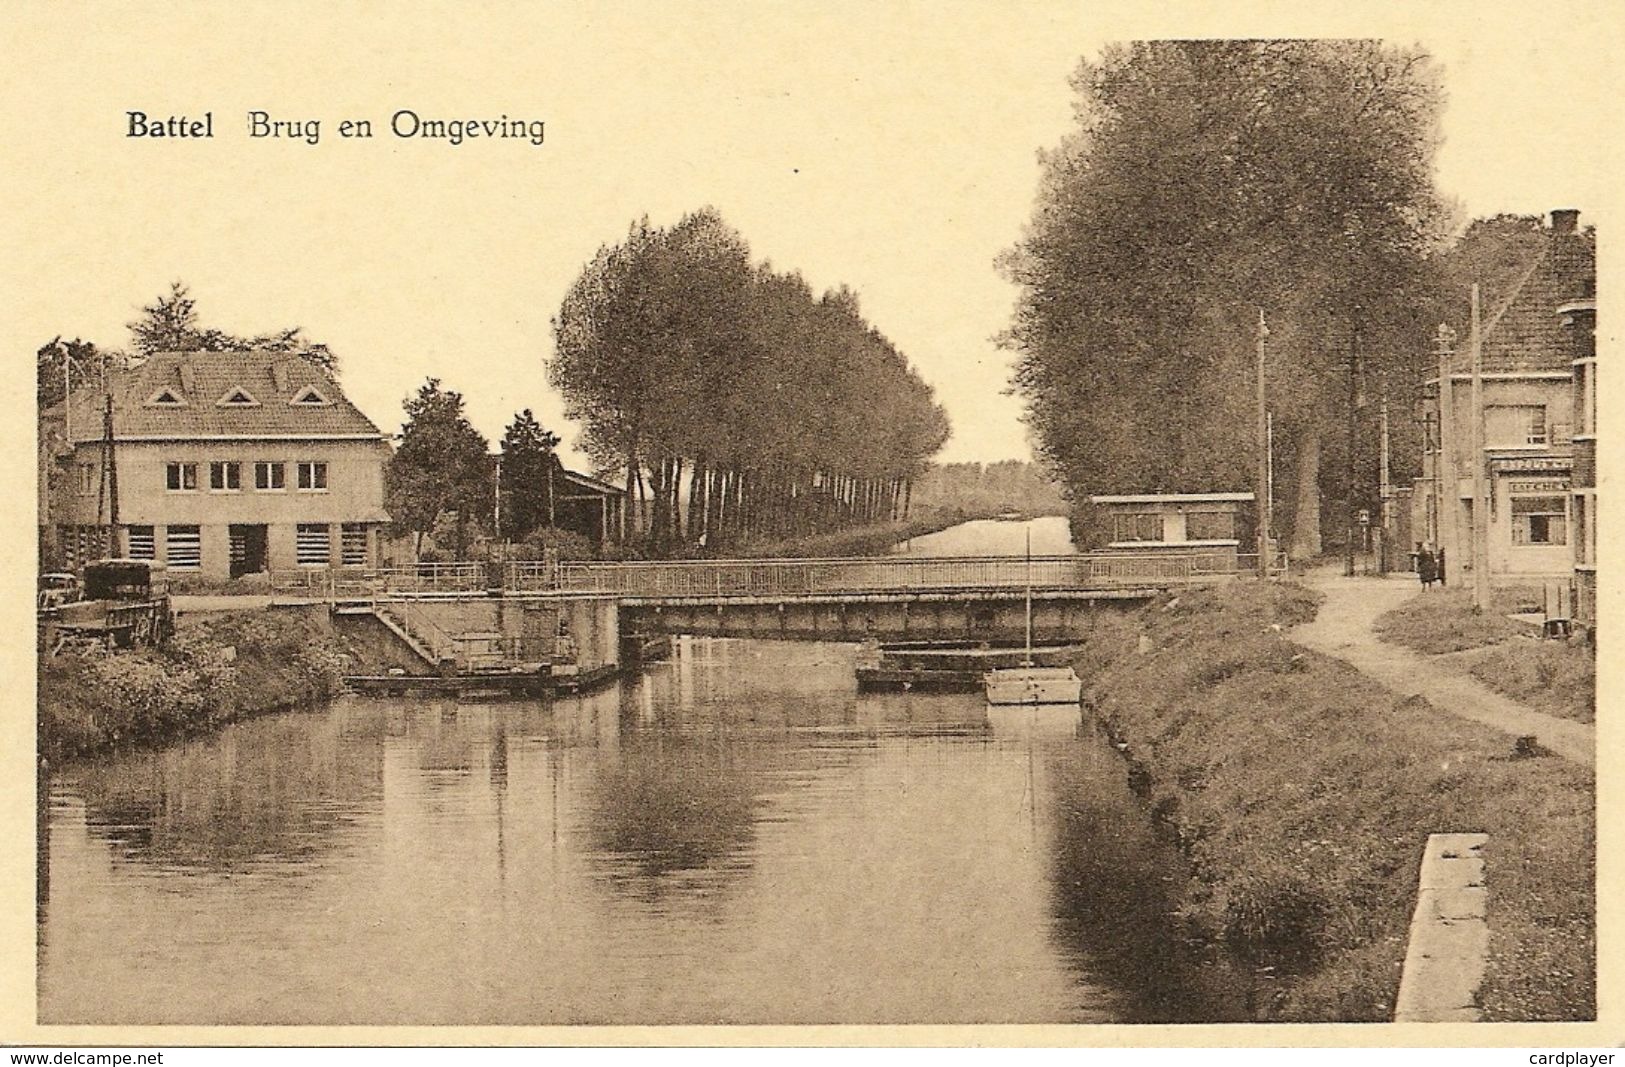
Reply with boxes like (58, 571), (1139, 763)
(1412, 210), (1596, 585)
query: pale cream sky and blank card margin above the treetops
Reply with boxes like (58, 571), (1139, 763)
(9, 2), (1622, 460)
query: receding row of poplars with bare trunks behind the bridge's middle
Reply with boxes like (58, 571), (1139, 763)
(548, 208), (949, 554)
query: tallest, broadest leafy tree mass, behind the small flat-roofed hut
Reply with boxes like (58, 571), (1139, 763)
(1003, 41), (1445, 551)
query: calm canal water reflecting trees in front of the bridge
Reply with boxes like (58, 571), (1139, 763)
(39, 520), (1251, 1023)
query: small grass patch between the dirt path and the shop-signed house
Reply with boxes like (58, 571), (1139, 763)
(1376, 590), (1597, 723)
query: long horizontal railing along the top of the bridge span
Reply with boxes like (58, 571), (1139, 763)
(546, 552), (1237, 598)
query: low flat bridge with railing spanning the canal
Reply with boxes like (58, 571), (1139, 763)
(312, 552), (1246, 661)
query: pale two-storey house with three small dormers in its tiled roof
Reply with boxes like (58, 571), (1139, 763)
(41, 351), (390, 578)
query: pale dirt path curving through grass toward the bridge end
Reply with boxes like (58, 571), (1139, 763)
(1292, 570), (1597, 767)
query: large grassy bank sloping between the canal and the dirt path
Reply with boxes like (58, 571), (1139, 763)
(1079, 583), (1596, 1022)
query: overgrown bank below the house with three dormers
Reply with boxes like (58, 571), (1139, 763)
(39, 609), (406, 762)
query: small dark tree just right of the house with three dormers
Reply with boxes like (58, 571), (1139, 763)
(384, 378), (494, 559)
